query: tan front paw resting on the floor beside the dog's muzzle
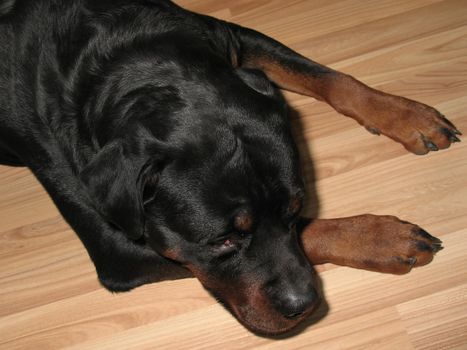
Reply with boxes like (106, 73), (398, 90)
(301, 214), (442, 274)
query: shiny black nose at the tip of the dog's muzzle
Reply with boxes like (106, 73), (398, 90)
(276, 288), (319, 318)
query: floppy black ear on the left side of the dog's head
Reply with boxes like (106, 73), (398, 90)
(80, 141), (148, 240)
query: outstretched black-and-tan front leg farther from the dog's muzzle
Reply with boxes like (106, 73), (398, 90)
(231, 24), (460, 154)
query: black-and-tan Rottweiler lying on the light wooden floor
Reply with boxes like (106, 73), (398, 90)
(0, 0), (460, 335)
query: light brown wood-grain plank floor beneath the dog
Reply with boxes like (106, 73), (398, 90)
(0, 0), (467, 350)
